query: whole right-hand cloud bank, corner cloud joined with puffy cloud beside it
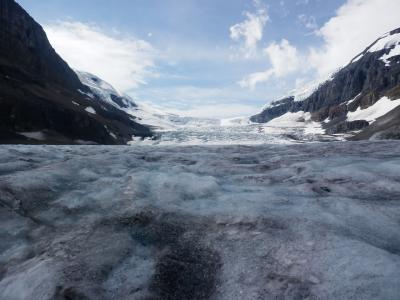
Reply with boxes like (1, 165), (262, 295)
(239, 0), (400, 89)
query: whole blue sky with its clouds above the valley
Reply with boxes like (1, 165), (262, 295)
(17, 0), (400, 118)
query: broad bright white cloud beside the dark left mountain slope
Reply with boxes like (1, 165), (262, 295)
(45, 22), (157, 91)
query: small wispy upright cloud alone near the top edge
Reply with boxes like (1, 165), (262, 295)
(230, 1), (269, 58)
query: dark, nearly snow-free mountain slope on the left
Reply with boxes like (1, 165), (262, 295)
(0, 0), (153, 144)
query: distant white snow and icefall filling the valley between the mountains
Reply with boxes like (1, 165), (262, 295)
(77, 71), (343, 145)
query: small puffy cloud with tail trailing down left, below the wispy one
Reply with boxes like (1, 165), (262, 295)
(239, 39), (300, 89)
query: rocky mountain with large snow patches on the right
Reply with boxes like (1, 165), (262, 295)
(250, 28), (400, 140)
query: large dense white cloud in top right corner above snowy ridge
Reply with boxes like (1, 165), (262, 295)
(309, 0), (400, 75)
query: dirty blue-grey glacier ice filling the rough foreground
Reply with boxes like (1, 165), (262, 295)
(0, 142), (400, 300)
